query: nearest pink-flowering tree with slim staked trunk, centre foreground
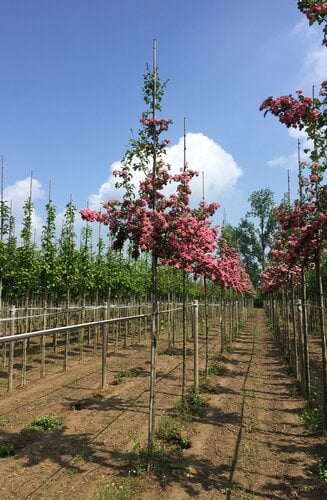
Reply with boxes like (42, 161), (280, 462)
(80, 61), (224, 469)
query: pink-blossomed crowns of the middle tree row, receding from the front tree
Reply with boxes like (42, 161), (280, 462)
(80, 95), (251, 293)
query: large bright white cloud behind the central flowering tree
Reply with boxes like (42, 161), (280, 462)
(89, 132), (243, 210)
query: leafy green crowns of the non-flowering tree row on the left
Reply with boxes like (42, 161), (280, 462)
(0, 193), (231, 307)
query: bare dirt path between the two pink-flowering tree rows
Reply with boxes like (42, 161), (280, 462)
(163, 310), (327, 499)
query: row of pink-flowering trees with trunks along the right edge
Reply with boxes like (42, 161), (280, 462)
(260, 0), (327, 429)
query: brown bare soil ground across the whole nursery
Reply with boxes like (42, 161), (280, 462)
(0, 310), (327, 500)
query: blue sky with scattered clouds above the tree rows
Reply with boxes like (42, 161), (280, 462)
(0, 0), (327, 239)
